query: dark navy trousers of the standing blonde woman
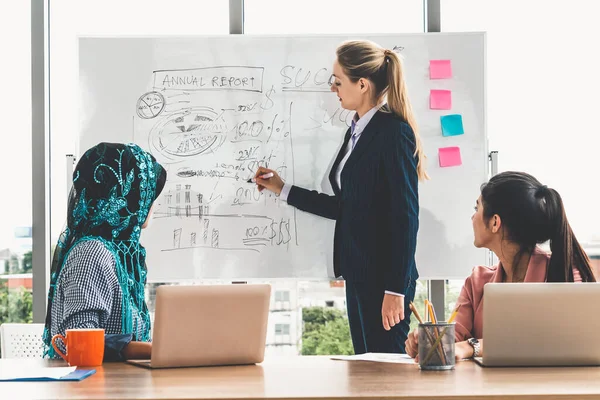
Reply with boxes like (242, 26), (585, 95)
(346, 281), (416, 354)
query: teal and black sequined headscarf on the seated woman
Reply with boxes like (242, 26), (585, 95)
(43, 143), (167, 357)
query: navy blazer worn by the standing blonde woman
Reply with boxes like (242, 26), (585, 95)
(287, 110), (419, 294)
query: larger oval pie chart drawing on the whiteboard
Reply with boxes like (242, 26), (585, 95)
(149, 107), (227, 162)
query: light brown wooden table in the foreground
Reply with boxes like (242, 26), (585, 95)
(0, 357), (600, 400)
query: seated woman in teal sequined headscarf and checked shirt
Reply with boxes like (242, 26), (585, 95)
(44, 143), (167, 360)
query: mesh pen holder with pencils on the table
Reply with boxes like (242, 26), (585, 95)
(418, 322), (455, 371)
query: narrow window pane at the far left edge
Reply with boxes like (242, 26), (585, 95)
(0, 1), (32, 332)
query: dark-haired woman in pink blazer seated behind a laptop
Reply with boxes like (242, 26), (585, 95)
(406, 172), (596, 359)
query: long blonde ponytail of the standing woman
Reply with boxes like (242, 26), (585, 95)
(384, 50), (429, 181)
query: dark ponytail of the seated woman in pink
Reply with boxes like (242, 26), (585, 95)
(540, 186), (596, 282)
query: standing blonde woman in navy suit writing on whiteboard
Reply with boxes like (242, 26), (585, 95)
(256, 41), (427, 354)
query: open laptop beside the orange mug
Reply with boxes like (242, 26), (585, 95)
(128, 284), (271, 368)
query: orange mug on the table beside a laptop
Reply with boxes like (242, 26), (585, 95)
(52, 329), (104, 367)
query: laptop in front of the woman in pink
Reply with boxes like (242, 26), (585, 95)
(475, 283), (600, 367)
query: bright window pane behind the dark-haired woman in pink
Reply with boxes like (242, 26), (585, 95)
(441, 0), (600, 312)
